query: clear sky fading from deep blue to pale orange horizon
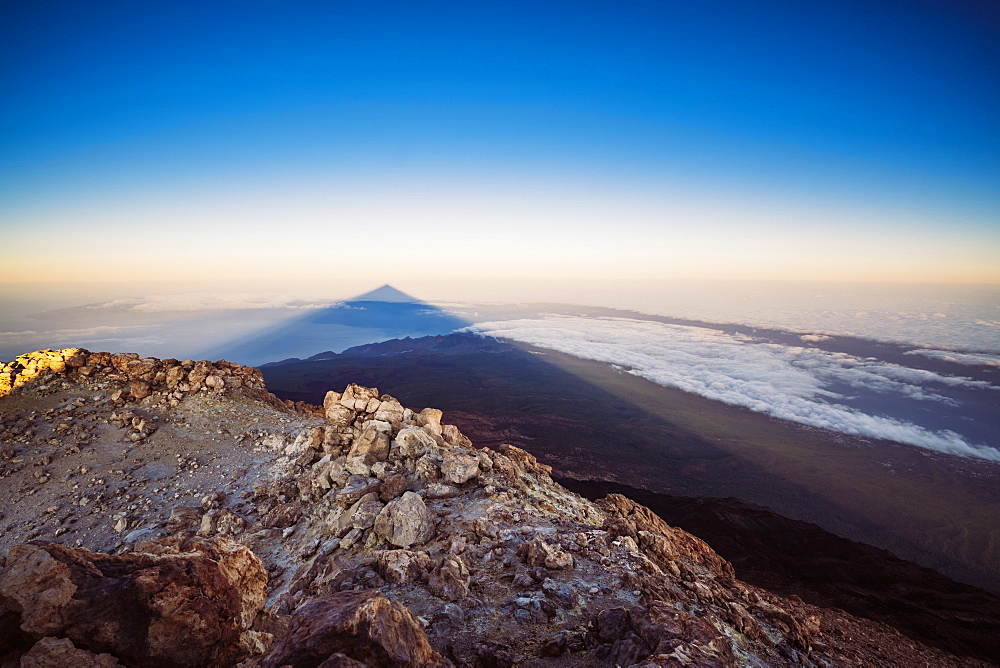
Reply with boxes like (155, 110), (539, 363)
(0, 0), (1000, 289)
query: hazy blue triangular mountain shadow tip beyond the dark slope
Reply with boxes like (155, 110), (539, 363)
(201, 285), (471, 365)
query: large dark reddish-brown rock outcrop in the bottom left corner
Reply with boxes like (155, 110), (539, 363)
(0, 539), (266, 666)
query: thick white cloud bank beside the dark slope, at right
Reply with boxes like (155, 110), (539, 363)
(470, 316), (1000, 461)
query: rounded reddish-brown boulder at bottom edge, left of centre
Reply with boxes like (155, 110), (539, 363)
(263, 590), (452, 668)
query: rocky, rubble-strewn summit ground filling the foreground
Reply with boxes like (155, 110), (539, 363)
(0, 349), (987, 668)
